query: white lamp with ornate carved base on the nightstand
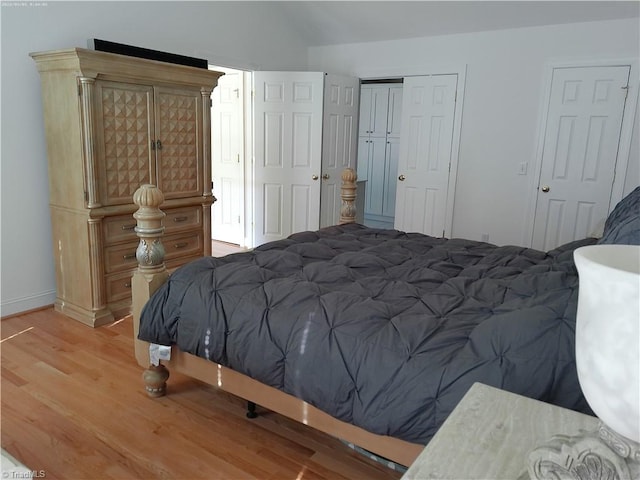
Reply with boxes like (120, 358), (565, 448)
(529, 245), (640, 480)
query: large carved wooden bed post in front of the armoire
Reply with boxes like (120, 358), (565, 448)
(131, 185), (169, 397)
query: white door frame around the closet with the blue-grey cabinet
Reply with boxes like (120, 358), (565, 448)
(353, 63), (467, 237)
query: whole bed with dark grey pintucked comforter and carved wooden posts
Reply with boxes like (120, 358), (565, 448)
(133, 170), (640, 465)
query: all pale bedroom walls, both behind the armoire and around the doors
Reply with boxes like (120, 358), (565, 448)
(0, 1), (640, 316)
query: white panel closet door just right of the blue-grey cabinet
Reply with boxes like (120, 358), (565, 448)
(394, 74), (458, 237)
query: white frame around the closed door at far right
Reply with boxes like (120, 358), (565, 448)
(522, 58), (640, 247)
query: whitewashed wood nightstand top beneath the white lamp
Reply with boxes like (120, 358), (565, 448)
(402, 383), (600, 480)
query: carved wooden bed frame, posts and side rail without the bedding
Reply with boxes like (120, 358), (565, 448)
(132, 168), (424, 466)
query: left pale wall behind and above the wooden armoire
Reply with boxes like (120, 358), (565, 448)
(0, 1), (307, 316)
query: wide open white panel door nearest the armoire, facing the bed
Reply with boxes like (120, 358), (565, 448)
(253, 72), (324, 245)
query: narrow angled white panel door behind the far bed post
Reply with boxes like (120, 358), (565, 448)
(320, 74), (360, 227)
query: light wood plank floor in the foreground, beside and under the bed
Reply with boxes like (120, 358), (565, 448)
(0, 308), (401, 480)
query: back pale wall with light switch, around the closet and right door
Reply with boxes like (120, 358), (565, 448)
(309, 18), (640, 245)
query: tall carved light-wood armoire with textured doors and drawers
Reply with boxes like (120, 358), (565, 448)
(31, 48), (222, 326)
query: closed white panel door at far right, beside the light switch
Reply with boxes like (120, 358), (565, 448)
(532, 66), (630, 251)
